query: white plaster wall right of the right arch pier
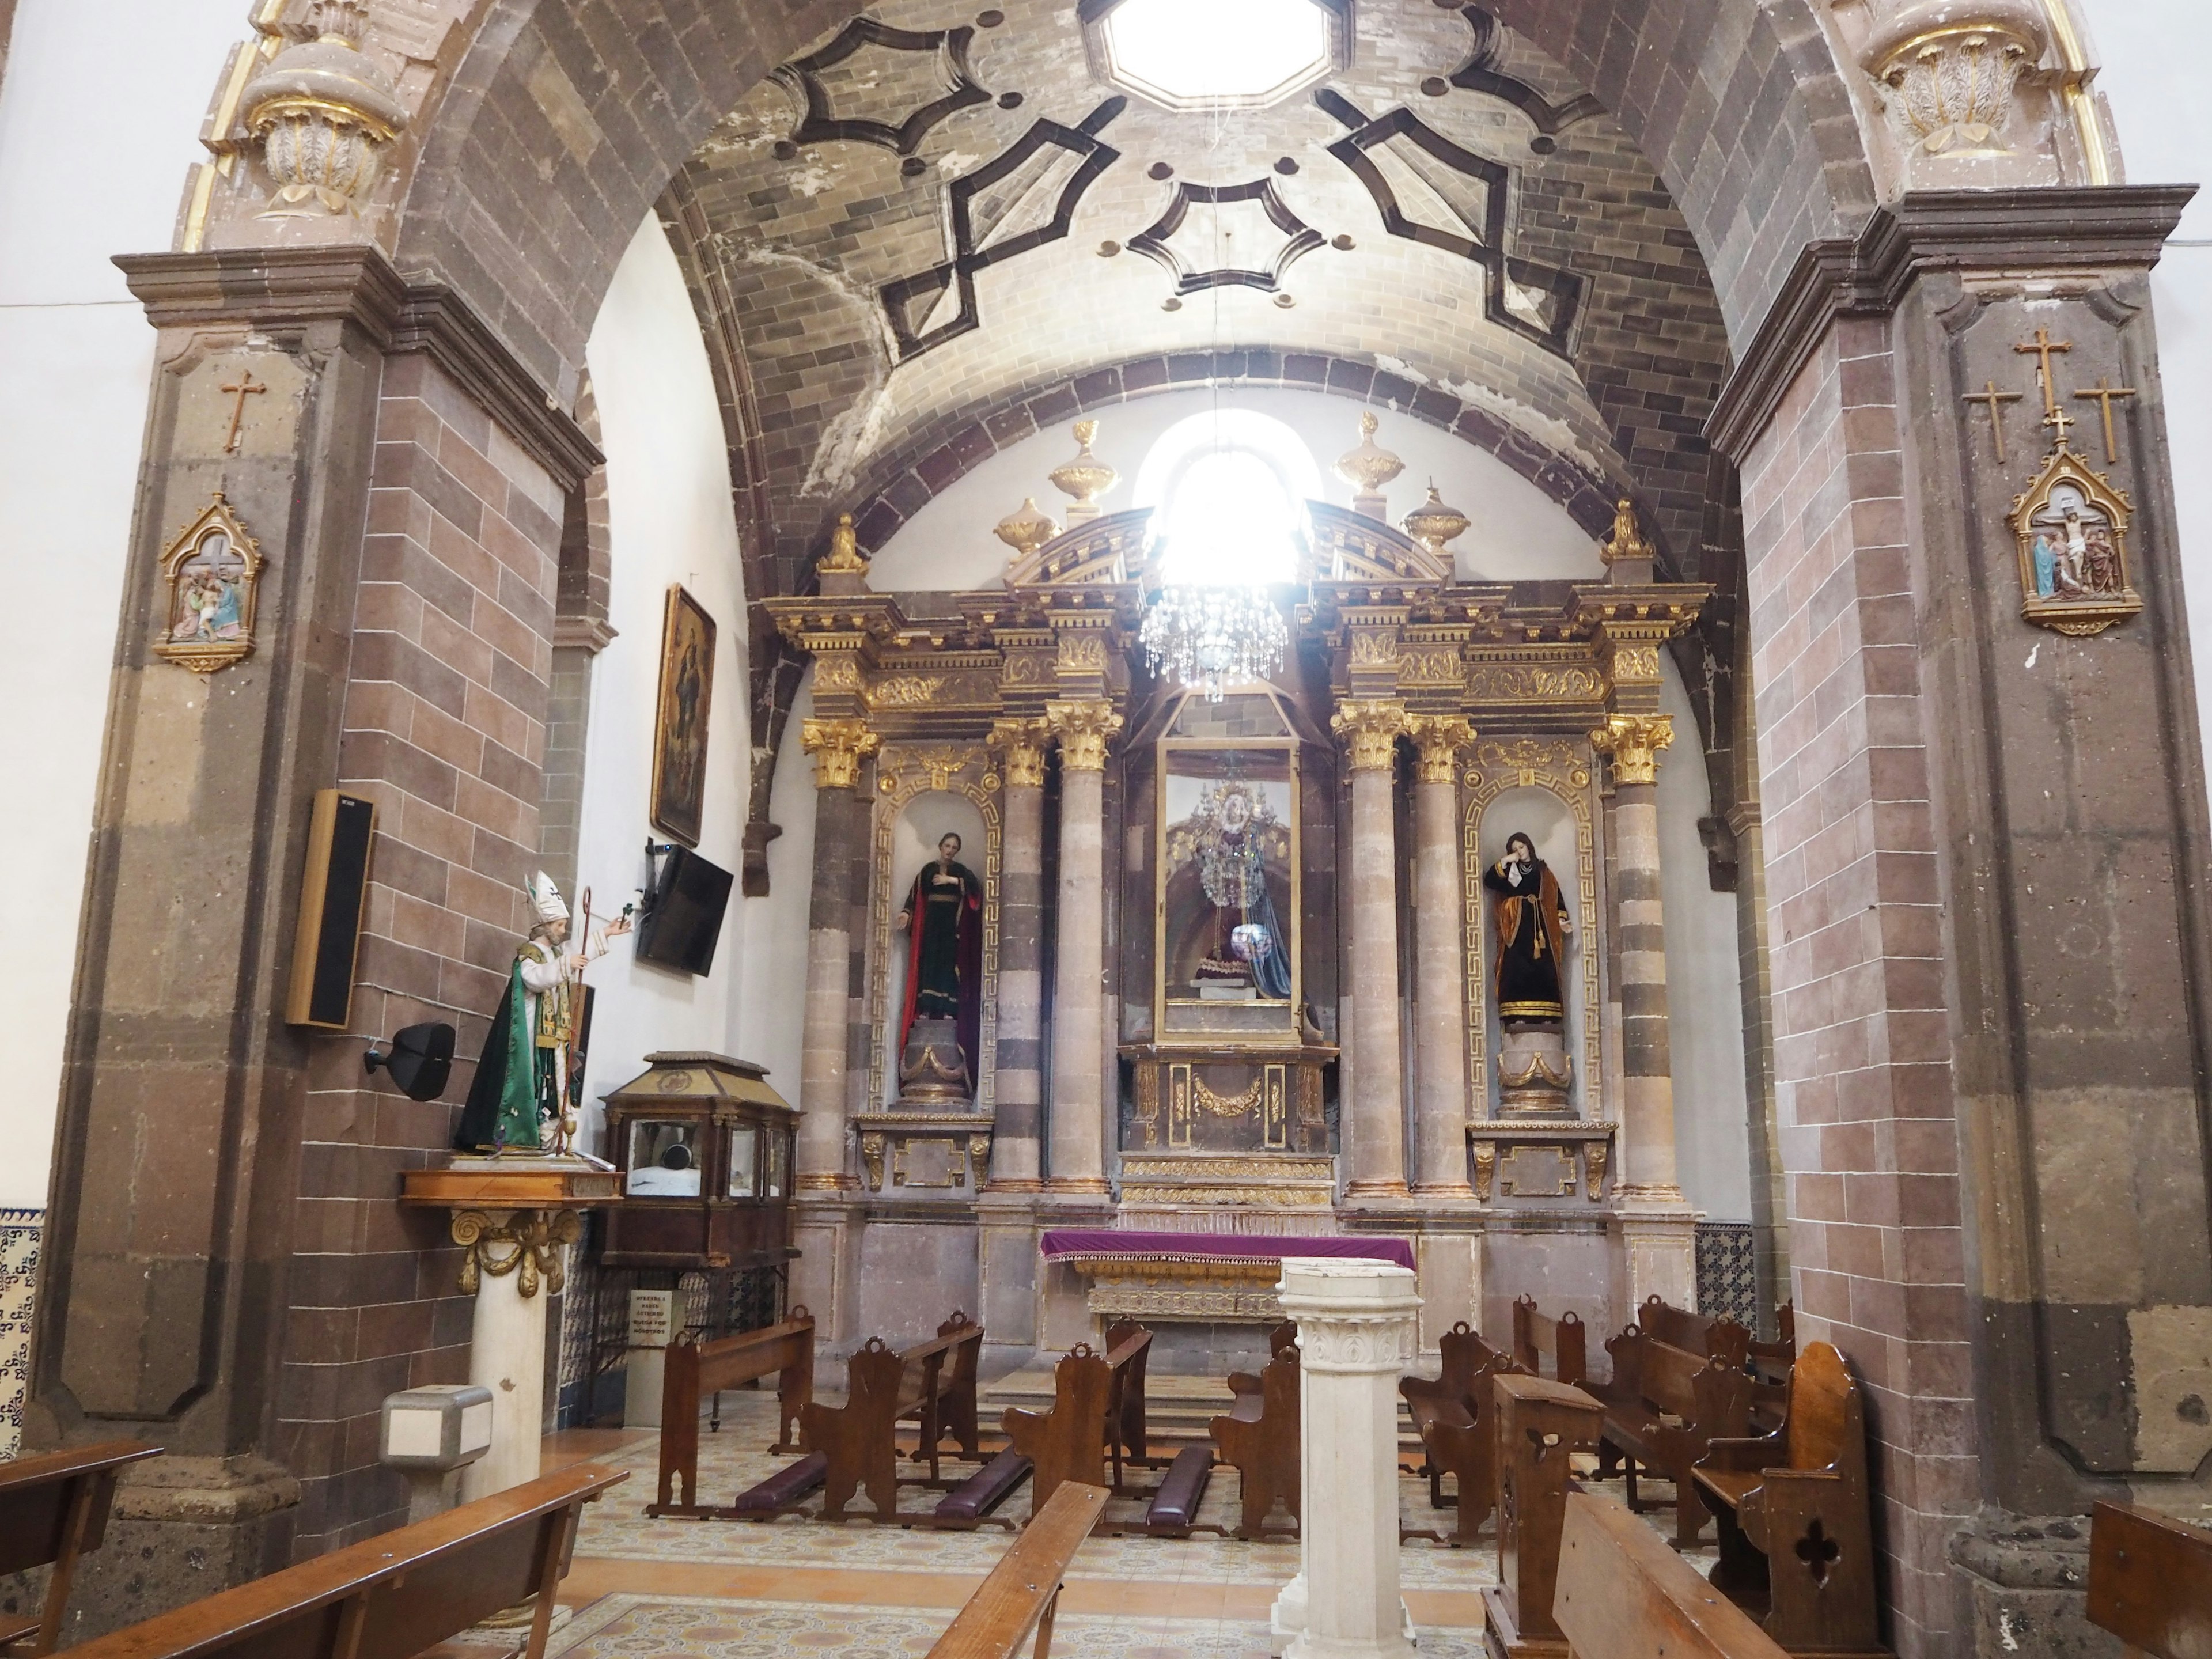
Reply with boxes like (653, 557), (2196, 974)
(2075, 0), (2212, 778)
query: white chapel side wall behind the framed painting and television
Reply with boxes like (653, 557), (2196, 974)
(571, 217), (765, 1146)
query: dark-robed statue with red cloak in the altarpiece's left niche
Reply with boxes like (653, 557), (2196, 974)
(892, 832), (982, 1101)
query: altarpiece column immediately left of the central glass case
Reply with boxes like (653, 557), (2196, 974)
(1044, 697), (1122, 1196)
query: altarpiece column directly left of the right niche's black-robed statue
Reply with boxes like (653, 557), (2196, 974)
(1411, 714), (1475, 1199)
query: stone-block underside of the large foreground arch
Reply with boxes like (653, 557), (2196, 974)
(398, 0), (1876, 396)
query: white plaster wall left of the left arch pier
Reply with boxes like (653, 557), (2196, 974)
(0, 0), (245, 1208)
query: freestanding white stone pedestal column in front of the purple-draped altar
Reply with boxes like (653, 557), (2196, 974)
(1267, 1256), (1420, 1659)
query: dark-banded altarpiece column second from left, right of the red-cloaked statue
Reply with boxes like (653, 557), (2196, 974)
(991, 719), (1051, 1192)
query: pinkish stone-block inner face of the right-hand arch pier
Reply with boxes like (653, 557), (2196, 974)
(1743, 321), (1978, 1659)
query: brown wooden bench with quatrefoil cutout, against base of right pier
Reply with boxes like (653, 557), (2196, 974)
(1696, 1343), (1883, 1654)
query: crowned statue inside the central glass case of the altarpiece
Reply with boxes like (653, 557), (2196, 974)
(1168, 761), (1290, 1002)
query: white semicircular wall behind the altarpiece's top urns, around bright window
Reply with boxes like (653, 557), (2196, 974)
(869, 387), (1606, 593)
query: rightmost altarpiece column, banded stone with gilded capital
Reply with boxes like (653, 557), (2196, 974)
(1590, 714), (1696, 1307)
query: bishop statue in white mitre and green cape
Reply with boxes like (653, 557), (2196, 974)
(453, 869), (630, 1153)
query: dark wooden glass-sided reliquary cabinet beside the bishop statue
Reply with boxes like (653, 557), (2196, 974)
(601, 1053), (798, 1270)
